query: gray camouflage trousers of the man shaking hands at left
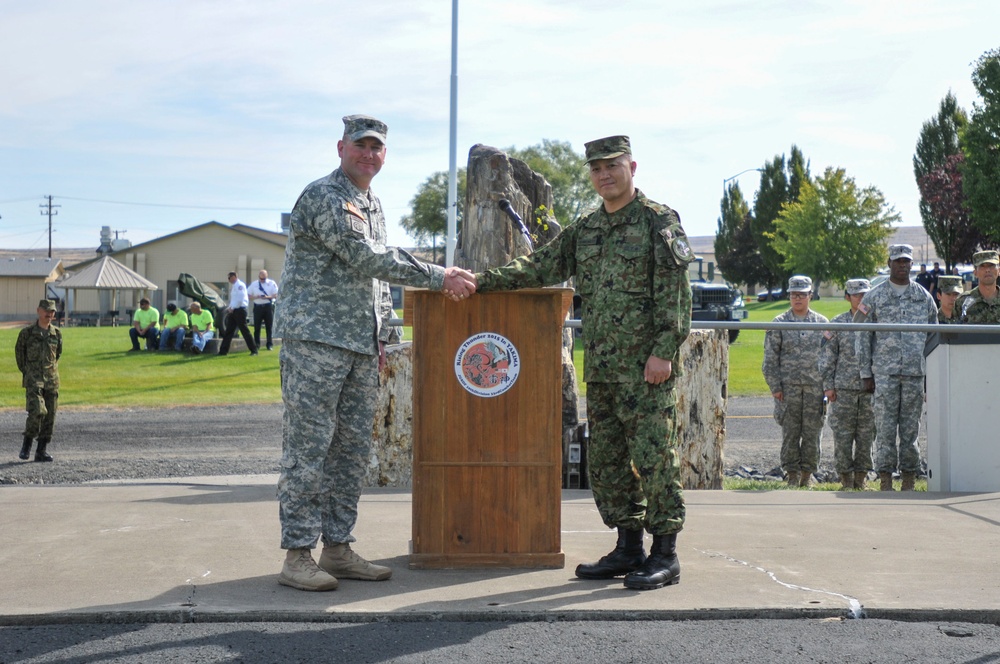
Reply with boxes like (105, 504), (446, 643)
(278, 339), (378, 549)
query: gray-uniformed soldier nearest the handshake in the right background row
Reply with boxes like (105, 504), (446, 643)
(762, 275), (829, 487)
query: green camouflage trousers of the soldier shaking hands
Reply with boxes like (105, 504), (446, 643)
(587, 383), (684, 535)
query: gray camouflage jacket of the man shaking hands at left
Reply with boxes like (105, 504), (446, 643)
(275, 168), (444, 355)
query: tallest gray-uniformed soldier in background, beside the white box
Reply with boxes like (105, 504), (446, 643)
(854, 244), (937, 491)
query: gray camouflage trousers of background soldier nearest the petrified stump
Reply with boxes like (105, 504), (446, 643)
(774, 385), (826, 473)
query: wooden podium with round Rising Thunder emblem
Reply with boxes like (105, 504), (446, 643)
(404, 288), (573, 569)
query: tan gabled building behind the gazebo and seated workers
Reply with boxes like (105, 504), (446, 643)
(63, 221), (288, 324)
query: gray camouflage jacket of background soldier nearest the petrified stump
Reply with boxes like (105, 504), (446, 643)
(761, 309), (829, 394)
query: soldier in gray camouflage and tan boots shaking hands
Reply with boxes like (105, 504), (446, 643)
(276, 115), (475, 590)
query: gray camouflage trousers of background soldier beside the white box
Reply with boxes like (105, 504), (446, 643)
(872, 376), (924, 473)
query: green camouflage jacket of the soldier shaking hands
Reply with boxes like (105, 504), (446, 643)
(476, 190), (694, 384)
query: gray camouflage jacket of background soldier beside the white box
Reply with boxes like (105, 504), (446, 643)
(854, 280), (937, 378)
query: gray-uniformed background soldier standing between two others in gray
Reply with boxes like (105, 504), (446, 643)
(819, 279), (875, 490)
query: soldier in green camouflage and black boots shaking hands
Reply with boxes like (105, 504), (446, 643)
(476, 136), (693, 589)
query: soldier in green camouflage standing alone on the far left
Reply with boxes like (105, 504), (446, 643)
(14, 300), (62, 461)
